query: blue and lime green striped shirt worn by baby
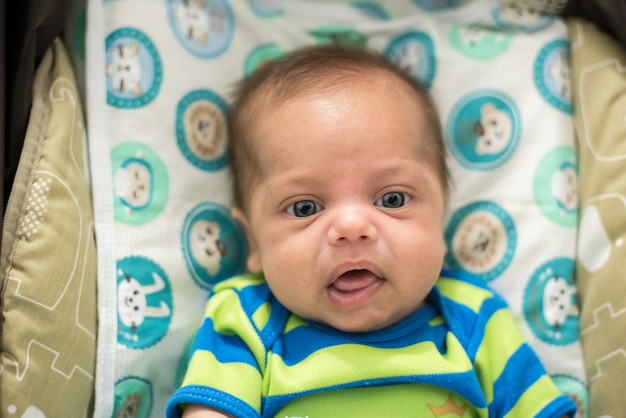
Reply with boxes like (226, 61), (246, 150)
(167, 272), (576, 418)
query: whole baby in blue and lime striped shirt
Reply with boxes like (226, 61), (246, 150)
(167, 46), (575, 418)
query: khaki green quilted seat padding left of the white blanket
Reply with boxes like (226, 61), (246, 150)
(0, 39), (97, 417)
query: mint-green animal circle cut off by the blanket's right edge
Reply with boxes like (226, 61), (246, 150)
(533, 145), (578, 228)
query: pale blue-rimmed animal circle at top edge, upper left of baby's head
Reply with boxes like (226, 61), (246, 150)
(167, 0), (235, 59)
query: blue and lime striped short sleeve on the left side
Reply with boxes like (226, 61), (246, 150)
(166, 281), (269, 417)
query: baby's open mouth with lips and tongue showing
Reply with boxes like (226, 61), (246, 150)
(326, 270), (385, 309)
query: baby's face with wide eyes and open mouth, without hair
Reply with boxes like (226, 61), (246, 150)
(236, 74), (445, 332)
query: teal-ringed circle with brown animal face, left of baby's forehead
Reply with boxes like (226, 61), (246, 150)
(176, 90), (228, 171)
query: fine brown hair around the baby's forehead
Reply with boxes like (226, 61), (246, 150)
(228, 45), (449, 213)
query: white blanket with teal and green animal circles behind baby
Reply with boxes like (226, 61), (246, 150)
(86, 0), (587, 417)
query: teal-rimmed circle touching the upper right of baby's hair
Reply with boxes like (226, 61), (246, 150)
(384, 31), (437, 88)
